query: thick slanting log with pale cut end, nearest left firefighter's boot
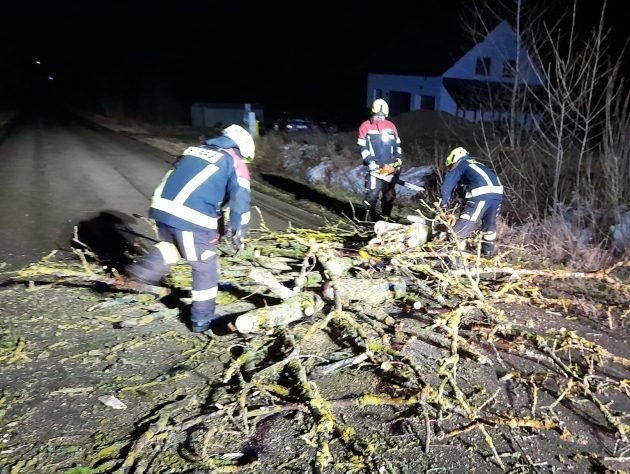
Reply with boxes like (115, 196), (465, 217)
(234, 293), (324, 334)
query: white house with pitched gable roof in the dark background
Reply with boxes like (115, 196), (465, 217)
(366, 21), (542, 122)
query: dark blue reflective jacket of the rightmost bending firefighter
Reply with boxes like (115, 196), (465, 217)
(440, 158), (503, 207)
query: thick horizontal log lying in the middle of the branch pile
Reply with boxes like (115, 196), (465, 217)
(323, 276), (407, 304)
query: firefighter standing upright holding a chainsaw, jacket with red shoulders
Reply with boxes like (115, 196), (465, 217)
(357, 99), (402, 221)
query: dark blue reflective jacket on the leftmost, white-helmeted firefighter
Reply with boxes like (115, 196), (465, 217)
(149, 137), (250, 236)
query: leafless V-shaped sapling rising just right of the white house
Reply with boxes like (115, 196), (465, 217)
(531, 0), (615, 208)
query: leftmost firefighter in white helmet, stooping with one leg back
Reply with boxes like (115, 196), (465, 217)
(126, 125), (255, 332)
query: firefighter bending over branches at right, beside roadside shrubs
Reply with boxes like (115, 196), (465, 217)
(440, 147), (503, 256)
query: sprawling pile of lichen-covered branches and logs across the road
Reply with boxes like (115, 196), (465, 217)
(11, 217), (630, 473)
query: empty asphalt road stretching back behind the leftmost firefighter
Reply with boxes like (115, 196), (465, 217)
(0, 114), (324, 270)
